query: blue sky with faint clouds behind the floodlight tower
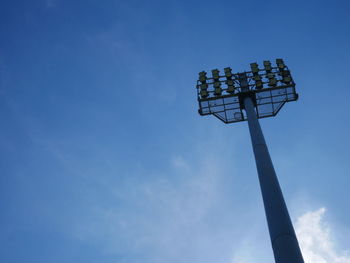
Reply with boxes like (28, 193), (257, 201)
(0, 0), (350, 263)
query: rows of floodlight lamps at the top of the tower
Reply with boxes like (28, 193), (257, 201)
(198, 58), (292, 99)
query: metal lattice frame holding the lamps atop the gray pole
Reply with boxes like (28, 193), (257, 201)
(196, 61), (298, 123)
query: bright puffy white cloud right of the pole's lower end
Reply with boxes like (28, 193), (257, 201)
(295, 207), (350, 263)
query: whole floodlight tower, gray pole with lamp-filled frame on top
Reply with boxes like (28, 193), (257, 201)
(196, 59), (304, 263)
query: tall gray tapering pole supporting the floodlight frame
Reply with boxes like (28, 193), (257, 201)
(244, 96), (304, 263)
